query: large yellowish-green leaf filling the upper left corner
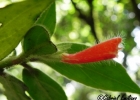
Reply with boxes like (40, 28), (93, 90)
(0, 0), (54, 60)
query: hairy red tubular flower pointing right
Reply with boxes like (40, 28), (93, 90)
(62, 37), (122, 64)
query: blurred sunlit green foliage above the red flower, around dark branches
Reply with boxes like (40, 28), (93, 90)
(54, 0), (139, 47)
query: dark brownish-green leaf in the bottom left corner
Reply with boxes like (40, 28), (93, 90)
(0, 75), (31, 100)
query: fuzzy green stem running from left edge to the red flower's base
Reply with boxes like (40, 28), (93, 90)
(0, 52), (61, 69)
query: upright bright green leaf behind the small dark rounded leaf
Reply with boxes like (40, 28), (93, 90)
(36, 3), (56, 36)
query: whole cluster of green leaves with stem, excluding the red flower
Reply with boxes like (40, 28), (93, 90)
(0, 0), (140, 100)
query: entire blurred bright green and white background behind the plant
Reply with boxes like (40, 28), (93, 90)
(0, 0), (140, 100)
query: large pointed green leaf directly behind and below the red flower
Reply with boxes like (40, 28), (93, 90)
(44, 43), (140, 94)
